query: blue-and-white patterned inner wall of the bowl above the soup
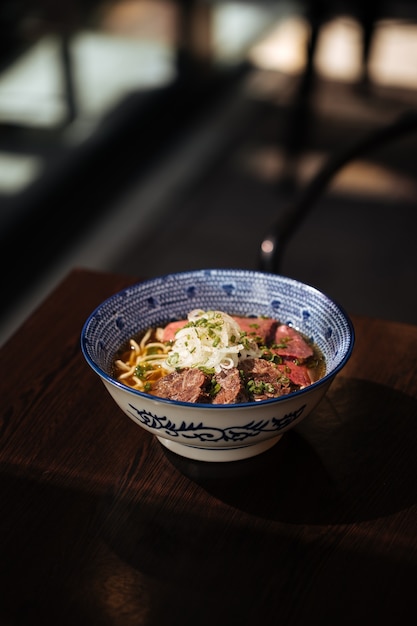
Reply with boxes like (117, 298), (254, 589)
(81, 269), (354, 390)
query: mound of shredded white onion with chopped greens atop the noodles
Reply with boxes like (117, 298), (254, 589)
(166, 309), (260, 373)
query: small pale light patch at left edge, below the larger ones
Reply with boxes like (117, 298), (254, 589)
(0, 152), (43, 195)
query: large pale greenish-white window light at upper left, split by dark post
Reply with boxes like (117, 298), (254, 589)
(0, 32), (175, 128)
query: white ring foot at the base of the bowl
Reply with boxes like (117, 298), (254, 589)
(157, 435), (282, 463)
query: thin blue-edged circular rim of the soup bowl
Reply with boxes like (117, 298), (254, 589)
(80, 268), (356, 411)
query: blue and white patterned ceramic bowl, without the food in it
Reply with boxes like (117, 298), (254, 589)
(81, 269), (354, 461)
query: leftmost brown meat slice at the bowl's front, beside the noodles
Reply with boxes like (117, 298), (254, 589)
(152, 368), (210, 403)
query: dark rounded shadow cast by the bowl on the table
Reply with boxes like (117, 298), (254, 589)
(166, 378), (417, 524)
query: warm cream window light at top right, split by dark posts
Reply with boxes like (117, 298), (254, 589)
(248, 15), (417, 89)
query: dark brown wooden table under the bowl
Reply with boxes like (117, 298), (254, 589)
(0, 270), (417, 626)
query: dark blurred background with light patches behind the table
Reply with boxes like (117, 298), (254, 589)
(0, 0), (417, 342)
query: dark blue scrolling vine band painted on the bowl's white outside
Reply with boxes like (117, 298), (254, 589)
(129, 404), (305, 443)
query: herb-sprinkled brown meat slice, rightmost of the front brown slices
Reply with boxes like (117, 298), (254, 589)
(239, 358), (291, 400)
